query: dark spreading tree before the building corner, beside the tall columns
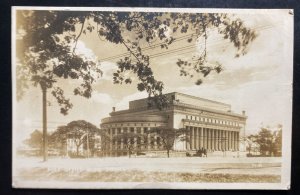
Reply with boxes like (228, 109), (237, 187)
(147, 126), (189, 158)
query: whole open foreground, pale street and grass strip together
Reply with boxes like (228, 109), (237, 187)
(14, 157), (282, 183)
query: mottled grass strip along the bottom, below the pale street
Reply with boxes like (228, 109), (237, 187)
(18, 168), (280, 183)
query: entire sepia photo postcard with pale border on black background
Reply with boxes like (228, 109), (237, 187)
(11, 6), (294, 190)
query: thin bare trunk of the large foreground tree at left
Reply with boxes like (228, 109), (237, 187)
(41, 84), (48, 162)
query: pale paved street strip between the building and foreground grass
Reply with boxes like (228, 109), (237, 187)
(15, 157), (281, 175)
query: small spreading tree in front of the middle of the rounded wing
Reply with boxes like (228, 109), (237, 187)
(112, 132), (147, 158)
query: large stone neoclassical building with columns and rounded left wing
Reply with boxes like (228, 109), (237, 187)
(101, 92), (247, 156)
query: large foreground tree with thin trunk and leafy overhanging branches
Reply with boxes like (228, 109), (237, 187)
(16, 10), (256, 161)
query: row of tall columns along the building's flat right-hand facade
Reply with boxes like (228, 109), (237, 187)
(186, 126), (239, 151)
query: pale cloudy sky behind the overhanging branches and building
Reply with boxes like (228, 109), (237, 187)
(13, 10), (293, 146)
